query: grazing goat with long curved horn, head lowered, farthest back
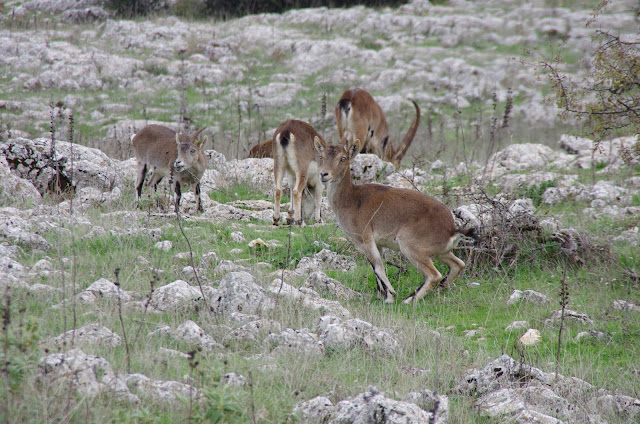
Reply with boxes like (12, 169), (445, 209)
(334, 88), (420, 168)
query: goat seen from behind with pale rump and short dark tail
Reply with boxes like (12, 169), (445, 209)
(272, 120), (324, 226)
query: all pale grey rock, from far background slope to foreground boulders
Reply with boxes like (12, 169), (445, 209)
(0, 0), (640, 423)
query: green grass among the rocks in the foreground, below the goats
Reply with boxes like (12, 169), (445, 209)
(2, 167), (640, 423)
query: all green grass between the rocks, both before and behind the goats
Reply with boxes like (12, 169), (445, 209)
(0, 1), (640, 423)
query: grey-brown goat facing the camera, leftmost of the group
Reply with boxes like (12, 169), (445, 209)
(131, 124), (208, 212)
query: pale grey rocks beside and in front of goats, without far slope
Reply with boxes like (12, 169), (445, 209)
(0, 131), (640, 423)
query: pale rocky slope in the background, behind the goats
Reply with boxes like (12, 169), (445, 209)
(0, 0), (638, 158)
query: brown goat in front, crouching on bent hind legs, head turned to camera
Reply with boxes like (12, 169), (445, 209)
(314, 137), (477, 303)
